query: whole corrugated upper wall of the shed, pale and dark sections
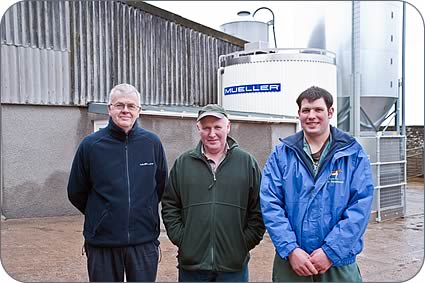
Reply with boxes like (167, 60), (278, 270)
(1, 1), (242, 106)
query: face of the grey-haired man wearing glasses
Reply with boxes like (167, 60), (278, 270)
(108, 93), (140, 133)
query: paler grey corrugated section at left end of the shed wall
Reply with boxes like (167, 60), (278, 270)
(0, 1), (72, 105)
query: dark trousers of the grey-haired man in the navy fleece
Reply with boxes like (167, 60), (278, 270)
(85, 242), (159, 282)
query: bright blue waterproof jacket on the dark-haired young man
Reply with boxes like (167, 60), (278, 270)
(260, 127), (374, 266)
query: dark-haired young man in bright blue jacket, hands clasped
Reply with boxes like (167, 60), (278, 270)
(260, 87), (374, 282)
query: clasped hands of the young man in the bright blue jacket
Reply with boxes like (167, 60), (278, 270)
(288, 248), (332, 276)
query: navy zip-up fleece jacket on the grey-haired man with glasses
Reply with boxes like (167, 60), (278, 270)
(68, 119), (168, 247)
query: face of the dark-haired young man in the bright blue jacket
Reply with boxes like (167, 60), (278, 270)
(298, 98), (334, 137)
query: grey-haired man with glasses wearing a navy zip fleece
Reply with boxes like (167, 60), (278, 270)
(68, 84), (168, 282)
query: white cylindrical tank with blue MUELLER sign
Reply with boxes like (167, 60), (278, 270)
(218, 49), (337, 125)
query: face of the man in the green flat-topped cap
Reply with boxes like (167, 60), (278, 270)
(198, 116), (230, 154)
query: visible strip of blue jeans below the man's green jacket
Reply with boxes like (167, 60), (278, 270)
(179, 264), (249, 282)
